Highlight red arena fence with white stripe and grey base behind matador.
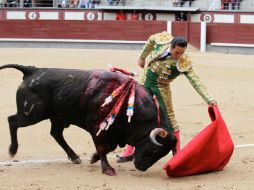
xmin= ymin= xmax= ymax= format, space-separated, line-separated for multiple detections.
xmin=0 ymin=20 xmax=254 ymax=54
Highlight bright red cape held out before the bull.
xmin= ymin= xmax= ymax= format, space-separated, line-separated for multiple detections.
xmin=163 ymin=106 xmax=234 ymax=176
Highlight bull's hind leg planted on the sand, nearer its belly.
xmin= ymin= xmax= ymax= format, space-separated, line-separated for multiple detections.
xmin=50 ymin=119 xmax=81 ymax=164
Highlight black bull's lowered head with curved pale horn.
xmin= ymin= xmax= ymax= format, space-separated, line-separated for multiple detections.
xmin=134 ymin=128 xmax=177 ymax=171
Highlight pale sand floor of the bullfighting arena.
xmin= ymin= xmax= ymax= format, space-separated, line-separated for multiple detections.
xmin=0 ymin=49 xmax=254 ymax=190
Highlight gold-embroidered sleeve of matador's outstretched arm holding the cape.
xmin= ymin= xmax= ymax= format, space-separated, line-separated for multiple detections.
xmin=184 ymin=68 xmax=214 ymax=104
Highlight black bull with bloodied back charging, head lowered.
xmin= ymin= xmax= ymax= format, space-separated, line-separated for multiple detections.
xmin=0 ymin=64 xmax=176 ymax=175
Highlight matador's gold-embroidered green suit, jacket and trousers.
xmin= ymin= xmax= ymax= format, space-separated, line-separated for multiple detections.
xmin=140 ymin=32 xmax=214 ymax=132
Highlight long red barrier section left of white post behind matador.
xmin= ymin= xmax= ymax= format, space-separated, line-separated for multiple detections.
xmin=0 ymin=20 xmax=167 ymax=41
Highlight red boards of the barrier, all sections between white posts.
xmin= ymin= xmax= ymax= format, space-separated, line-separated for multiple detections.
xmin=0 ymin=20 xmax=254 ymax=48
